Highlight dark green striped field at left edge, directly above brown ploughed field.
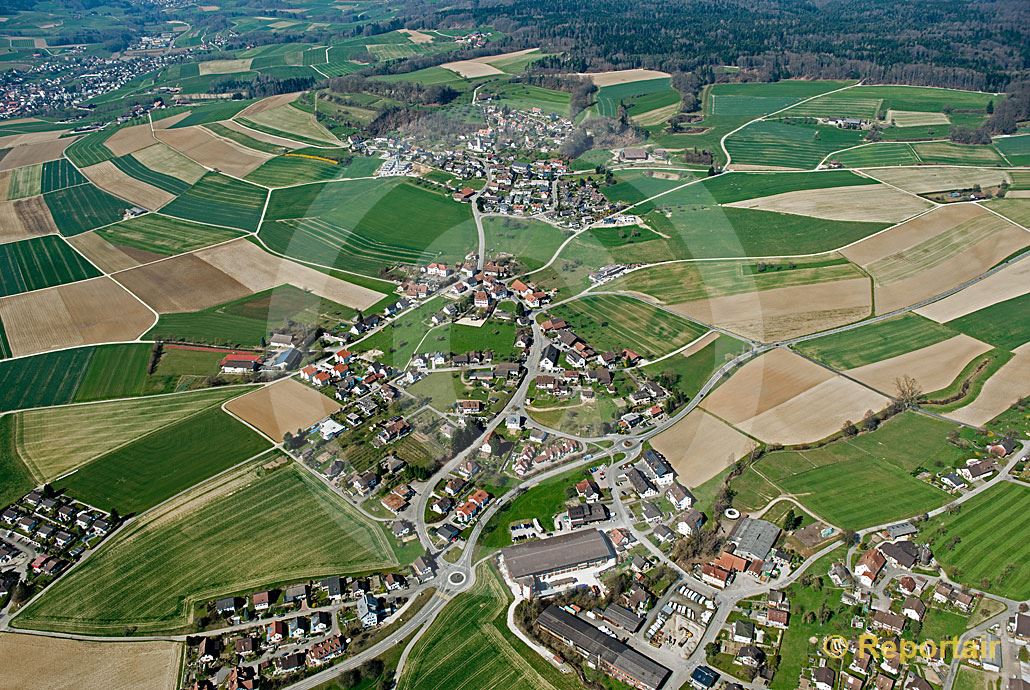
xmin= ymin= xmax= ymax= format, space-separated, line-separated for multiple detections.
xmin=0 ymin=235 xmax=100 ymax=297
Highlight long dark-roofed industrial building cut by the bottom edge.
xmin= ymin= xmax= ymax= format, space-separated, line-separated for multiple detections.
xmin=537 ymin=605 xmax=671 ymax=690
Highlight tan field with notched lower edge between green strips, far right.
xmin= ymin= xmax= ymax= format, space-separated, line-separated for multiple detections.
xmin=847 ymin=335 xmax=991 ymax=395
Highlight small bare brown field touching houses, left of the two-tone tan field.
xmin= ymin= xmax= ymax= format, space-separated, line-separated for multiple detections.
xmin=651 ymin=408 xmax=758 ymax=486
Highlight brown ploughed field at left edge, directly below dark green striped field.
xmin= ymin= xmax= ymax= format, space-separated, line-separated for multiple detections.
xmin=0 ymin=277 xmax=155 ymax=356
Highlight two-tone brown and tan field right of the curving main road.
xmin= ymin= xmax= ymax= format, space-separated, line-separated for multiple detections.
xmin=701 ymin=349 xmax=889 ymax=445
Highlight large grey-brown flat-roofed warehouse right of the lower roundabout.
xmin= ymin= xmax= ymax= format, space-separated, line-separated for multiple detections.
xmin=502 ymin=529 xmax=615 ymax=598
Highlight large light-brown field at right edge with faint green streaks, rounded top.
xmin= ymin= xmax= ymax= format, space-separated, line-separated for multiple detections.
xmin=840 ymin=204 xmax=1030 ymax=313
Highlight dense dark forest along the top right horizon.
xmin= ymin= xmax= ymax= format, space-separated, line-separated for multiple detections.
xmin=397 ymin=0 xmax=1030 ymax=91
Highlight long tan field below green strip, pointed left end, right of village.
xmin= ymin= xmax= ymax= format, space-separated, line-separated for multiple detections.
xmin=670 ymin=278 xmax=872 ymax=342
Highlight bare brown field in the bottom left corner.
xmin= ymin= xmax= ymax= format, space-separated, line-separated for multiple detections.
xmin=0 ymin=632 xmax=181 ymax=690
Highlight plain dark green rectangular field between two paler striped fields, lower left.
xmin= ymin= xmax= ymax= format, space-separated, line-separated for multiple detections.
xmin=57 ymin=408 xmax=270 ymax=515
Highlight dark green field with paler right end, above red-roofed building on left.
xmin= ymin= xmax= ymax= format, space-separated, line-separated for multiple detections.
xmin=145 ymin=284 xmax=355 ymax=347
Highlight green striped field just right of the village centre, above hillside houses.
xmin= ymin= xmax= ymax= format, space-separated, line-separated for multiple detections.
xmin=551 ymin=295 xmax=707 ymax=358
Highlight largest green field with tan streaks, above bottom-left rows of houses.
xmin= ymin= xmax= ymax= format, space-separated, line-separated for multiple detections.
xmin=16 ymin=460 xmax=399 ymax=635
